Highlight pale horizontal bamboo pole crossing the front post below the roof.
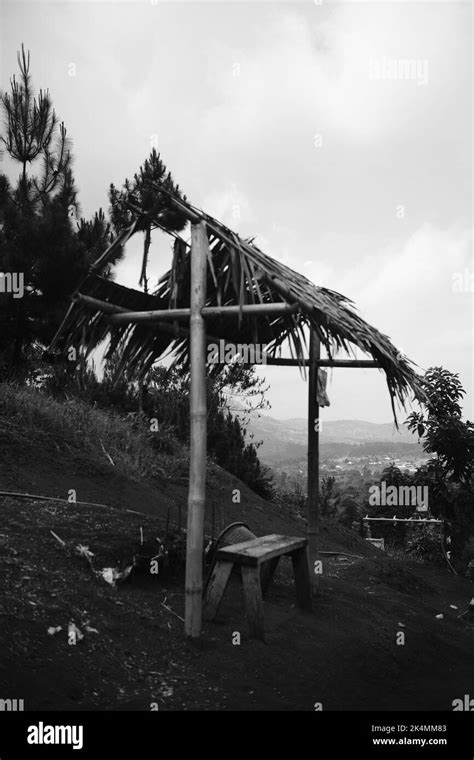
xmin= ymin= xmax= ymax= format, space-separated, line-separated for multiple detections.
xmin=110 ymin=302 xmax=298 ymax=324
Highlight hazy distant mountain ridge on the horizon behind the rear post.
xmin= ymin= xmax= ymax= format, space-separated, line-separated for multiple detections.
xmin=247 ymin=415 xmax=421 ymax=464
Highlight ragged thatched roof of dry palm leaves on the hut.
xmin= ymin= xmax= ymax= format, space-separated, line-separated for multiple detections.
xmin=52 ymin=185 xmax=423 ymax=422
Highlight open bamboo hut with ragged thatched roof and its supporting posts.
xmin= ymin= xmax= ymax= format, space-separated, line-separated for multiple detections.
xmin=51 ymin=183 xmax=423 ymax=636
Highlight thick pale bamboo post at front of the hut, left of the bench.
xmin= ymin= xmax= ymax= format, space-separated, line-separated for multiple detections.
xmin=184 ymin=222 xmax=208 ymax=638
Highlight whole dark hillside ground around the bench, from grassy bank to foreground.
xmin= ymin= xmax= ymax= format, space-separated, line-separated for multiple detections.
xmin=0 ymin=386 xmax=474 ymax=710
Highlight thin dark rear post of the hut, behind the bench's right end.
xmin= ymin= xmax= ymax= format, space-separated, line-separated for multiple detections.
xmin=307 ymin=330 xmax=321 ymax=596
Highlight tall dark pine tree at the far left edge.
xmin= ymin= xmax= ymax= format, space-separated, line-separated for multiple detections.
xmin=0 ymin=45 xmax=108 ymax=376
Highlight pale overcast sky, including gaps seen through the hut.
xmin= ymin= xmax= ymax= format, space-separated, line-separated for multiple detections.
xmin=0 ymin=0 xmax=474 ymax=422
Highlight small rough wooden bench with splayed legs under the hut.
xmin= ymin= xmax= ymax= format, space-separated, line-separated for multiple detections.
xmin=203 ymin=534 xmax=311 ymax=641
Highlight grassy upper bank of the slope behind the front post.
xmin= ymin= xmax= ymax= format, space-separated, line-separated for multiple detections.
xmin=0 ymin=386 xmax=378 ymax=553
